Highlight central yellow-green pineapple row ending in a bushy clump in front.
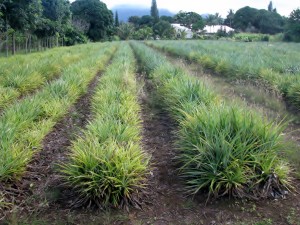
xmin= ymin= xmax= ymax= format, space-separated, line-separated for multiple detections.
xmin=62 ymin=43 xmax=149 ymax=207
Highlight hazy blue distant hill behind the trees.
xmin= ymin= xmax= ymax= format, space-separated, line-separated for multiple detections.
xmin=111 ymin=5 xmax=175 ymax=22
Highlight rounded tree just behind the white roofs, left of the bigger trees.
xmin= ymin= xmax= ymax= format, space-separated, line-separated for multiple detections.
xmin=174 ymin=11 xmax=204 ymax=30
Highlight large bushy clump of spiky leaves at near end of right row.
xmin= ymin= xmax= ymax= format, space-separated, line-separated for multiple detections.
xmin=177 ymin=105 xmax=289 ymax=197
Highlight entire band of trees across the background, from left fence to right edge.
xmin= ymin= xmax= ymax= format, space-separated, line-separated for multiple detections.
xmin=0 ymin=0 xmax=300 ymax=55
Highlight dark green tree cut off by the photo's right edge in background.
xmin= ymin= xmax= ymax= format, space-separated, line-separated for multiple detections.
xmin=285 ymin=8 xmax=300 ymax=42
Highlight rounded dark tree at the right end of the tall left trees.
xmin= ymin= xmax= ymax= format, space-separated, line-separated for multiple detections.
xmin=71 ymin=0 xmax=114 ymax=41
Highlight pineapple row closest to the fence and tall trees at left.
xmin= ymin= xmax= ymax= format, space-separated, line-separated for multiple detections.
xmin=0 ymin=45 xmax=93 ymax=109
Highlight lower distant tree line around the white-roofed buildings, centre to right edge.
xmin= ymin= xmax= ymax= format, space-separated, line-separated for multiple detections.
xmin=118 ymin=0 xmax=300 ymax=41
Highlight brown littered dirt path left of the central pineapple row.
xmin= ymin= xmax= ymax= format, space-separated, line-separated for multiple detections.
xmin=0 ymin=67 xmax=105 ymax=221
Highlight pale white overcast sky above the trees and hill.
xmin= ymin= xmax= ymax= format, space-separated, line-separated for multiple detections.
xmin=102 ymin=0 xmax=300 ymax=17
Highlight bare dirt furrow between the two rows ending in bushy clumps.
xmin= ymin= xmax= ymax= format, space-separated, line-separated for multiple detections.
xmin=132 ymin=75 xmax=190 ymax=224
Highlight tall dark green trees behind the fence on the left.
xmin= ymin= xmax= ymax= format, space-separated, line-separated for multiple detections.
xmin=0 ymin=0 xmax=113 ymax=55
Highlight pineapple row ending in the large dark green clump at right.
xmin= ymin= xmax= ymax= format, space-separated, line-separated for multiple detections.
xmin=131 ymin=42 xmax=290 ymax=198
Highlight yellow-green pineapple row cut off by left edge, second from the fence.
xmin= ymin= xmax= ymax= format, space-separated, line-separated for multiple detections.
xmin=0 ymin=44 xmax=117 ymax=182
